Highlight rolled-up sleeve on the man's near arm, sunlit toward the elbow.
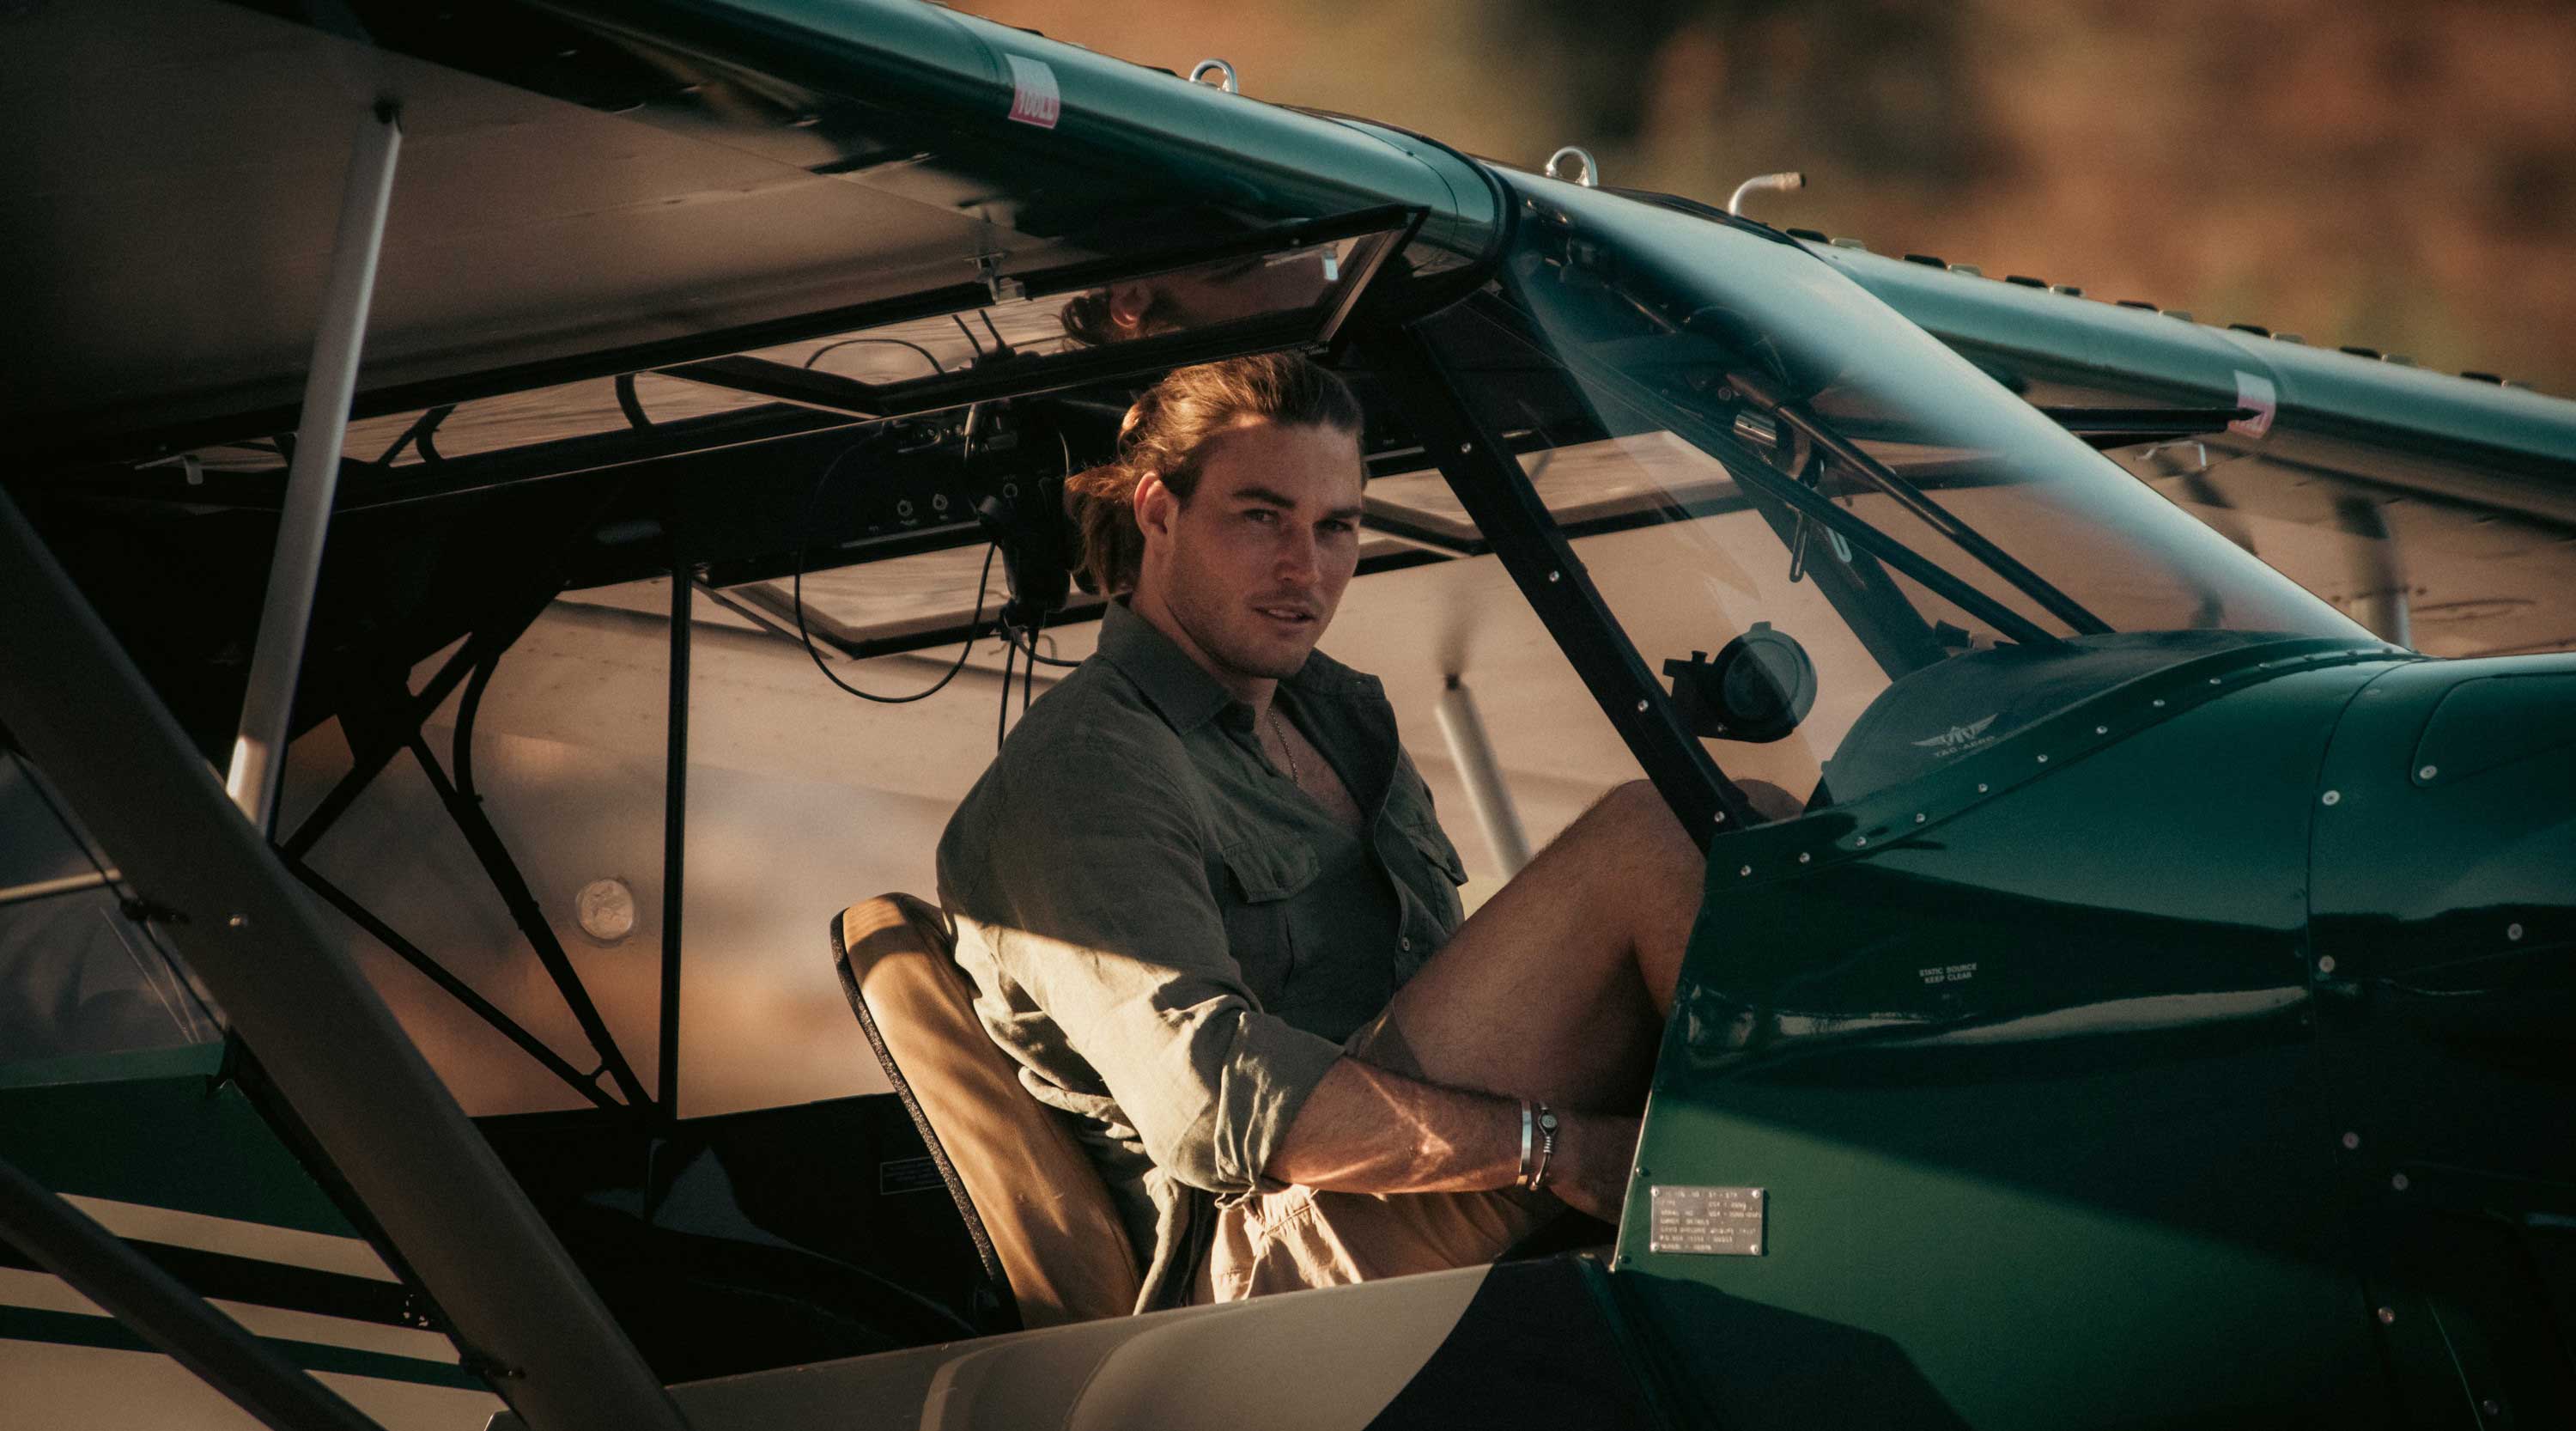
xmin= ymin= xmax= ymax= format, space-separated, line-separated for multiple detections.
xmin=940 ymin=740 xmax=1342 ymax=1194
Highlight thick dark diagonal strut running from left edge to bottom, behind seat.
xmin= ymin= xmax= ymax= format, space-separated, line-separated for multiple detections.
xmin=0 ymin=492 xmax=688 ymax=1431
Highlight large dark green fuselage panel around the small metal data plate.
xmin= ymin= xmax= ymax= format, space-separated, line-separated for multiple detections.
xmin=1615 ymin=642 xmax=2393 ymax=1428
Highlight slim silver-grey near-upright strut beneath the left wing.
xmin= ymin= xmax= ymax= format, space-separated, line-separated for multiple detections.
xmin=224 ymin=100 xmax=402 ymax=833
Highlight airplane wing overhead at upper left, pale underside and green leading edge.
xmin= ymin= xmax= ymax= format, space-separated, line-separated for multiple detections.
xmin=0 ymin=0 xmax=1497 ymax=474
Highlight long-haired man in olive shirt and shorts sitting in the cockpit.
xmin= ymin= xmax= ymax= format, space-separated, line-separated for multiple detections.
xmin=938 ymin=356 xmax=1703 ymax=1307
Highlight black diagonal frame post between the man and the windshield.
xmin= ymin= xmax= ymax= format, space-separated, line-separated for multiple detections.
xmin=1358 ymin=322 xmax=1762 ymax=849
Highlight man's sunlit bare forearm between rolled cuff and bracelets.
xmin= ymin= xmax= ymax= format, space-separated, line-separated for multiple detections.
xmin=1267 ymin=1057 xmax=1520 ymax=1194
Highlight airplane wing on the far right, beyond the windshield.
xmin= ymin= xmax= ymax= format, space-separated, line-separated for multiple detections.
xmin=1798 ymin=232 xmax=2576 ymax=657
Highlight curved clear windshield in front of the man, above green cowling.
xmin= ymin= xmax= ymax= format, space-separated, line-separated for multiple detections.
xmin=1412 ymin=173 xmax=2378 ymax=815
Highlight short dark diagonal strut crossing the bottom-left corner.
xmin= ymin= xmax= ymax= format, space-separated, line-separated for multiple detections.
xmin=0 ymin=1158 xmax=384 ymax=1431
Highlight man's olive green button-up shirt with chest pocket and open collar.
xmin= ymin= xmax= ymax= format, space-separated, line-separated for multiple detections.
xmin=938 ymin=603 xmax=1466 ymax=1310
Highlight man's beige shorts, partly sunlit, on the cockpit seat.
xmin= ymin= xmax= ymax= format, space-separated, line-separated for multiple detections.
xmin=1193 ymin=1014 xmax=1564 ymax=1302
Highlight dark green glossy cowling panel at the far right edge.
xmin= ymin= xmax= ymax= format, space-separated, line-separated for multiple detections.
xmin=2313 ymin=655 xmax=2576 ymax=1426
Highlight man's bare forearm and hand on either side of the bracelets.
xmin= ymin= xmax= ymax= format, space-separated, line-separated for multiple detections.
xmin=1265 ymin=1057 xmax=1636 ymax=1222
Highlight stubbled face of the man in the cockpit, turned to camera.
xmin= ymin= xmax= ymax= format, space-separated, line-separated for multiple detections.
xmin=1136 ymin=420 xmax=1360 ymax=693
